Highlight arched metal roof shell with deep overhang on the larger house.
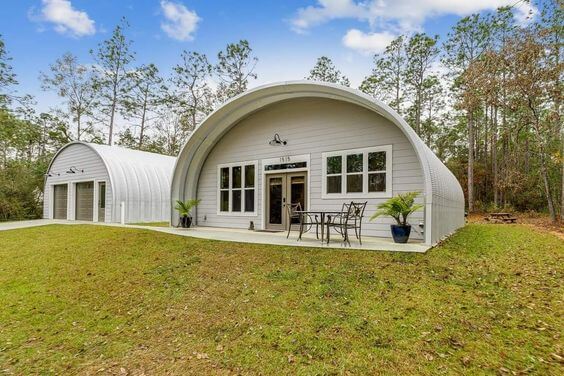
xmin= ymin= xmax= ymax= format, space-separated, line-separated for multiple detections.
xmin=171 ymin=81 xmax=464 ymax=244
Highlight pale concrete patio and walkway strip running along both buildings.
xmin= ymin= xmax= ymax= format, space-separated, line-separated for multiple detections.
xmin=0 ymin=219 xmax=430 ymax=253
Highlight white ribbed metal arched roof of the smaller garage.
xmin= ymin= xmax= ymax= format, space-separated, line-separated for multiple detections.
xmin=48 ymin=141 xmax=176 ymax=221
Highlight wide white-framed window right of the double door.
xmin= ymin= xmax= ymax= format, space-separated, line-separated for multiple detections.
xmin=322 ymin=145 xmax=392 ymax=198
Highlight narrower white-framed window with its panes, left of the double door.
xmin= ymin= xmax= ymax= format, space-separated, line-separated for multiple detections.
xmin=217 ymin=162 xmax=257 ymax=215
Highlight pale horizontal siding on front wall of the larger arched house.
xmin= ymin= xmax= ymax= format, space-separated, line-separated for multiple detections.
xmin=197 ymin=98 xmax=424 ymax=239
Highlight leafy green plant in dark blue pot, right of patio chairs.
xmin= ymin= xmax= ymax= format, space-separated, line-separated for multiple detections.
xmin=370 ymin=192 xmax=423 ymax=243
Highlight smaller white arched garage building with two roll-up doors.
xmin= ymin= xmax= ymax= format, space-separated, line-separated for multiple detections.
xmin=43 ymin=141 xmax=176 ymax=223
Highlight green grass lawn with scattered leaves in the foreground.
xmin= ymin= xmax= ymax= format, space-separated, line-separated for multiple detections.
xmin=0 ymin=224 xmax=564 ymax=375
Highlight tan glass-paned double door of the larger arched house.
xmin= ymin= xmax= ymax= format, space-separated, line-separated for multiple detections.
xmin=266 ymin=172 xmax=307 ymax=230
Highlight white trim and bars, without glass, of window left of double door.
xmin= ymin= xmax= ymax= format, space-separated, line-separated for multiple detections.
xmin=216 ymin=160 xmax=258 ymax=217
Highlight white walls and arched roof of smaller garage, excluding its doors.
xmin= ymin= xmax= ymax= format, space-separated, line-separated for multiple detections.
xmin=44 ymin=142 xmax=176 ymax=222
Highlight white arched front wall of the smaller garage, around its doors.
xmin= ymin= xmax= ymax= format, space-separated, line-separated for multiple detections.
xmin=43 ymin=143 xmax=113 ymax=222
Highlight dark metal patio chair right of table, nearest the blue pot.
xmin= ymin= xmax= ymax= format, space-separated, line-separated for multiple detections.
xmin=327 ymin=201 xmax=368 ymax=246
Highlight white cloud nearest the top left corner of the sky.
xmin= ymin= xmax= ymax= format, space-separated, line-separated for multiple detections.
xmin=35 ymin=0 xmax=96 ymax=38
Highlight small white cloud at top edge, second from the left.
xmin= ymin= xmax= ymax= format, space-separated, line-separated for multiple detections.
xmin=161 ymin=0 xmax=201 ymax=41
